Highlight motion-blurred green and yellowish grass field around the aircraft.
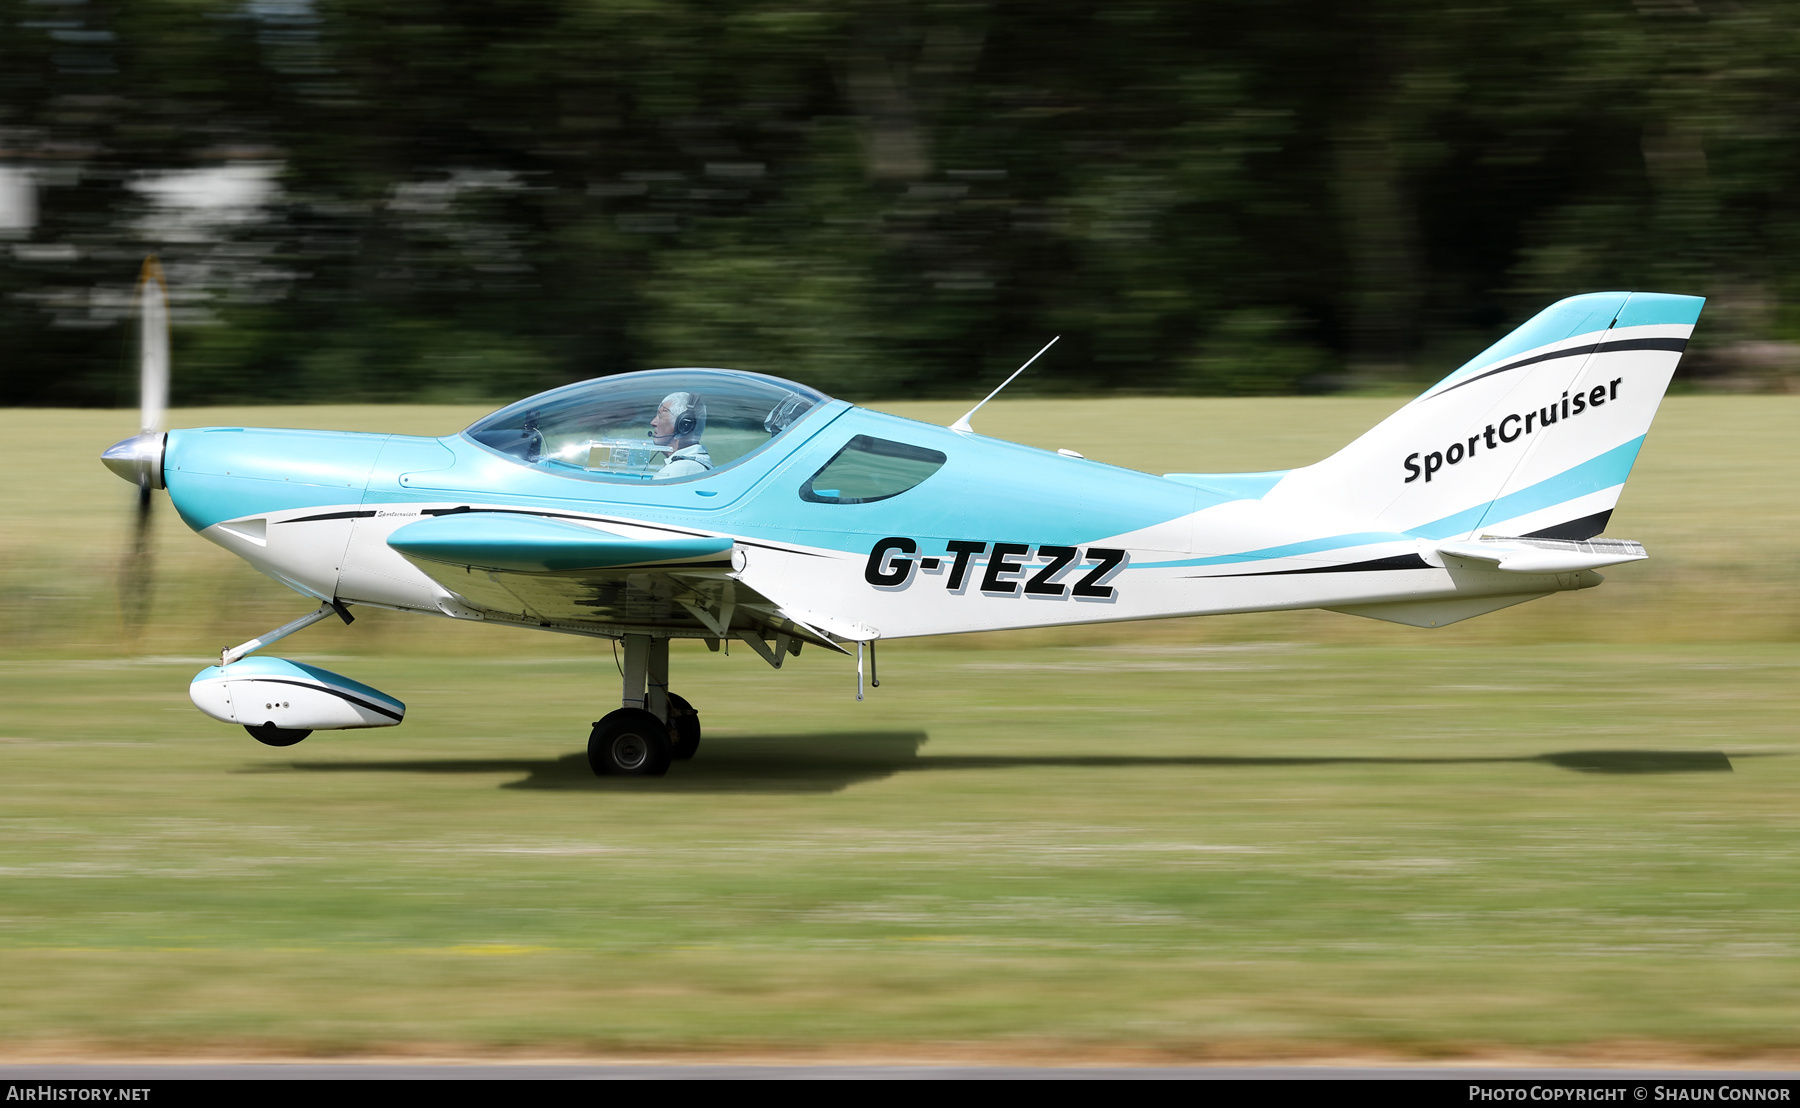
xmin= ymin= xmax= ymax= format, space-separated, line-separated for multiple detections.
xmin=0 ymin=398 xmax=1800 ymax=1061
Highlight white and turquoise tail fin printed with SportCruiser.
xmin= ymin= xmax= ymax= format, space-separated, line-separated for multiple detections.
xmin=1271 ymin=293 xmax=1705 ymax=540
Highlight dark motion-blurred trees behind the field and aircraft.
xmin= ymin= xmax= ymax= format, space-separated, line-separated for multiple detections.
xmin=0 ymin=0 xmax=1800 ymax=405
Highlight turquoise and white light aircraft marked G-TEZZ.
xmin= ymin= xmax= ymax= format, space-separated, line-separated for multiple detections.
xmin=103 ymin=275 xmax=1703 ymax=775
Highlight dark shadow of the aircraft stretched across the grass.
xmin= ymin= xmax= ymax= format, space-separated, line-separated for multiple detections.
xmin=263 ymin=730 xmax=1732 ymax=793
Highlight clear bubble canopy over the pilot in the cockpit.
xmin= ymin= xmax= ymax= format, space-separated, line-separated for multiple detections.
xmin=463 ymin=369 xmax=832 ymax=482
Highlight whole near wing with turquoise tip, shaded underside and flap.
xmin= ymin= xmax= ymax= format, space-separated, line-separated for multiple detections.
xmin=387 ymin=509 xmax=848 ymax=666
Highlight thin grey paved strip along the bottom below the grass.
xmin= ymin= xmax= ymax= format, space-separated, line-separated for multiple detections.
xmin=0 ymin=1063 xmax=1800 ymax=1085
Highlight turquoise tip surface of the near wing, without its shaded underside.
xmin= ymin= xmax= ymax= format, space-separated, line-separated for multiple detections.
xmin=387 ymin=511 xmax=733 ymax=574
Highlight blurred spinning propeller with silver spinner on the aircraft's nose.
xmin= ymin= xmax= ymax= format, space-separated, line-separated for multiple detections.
xmin=115 ymin=255 xmax=169 ymax=625
